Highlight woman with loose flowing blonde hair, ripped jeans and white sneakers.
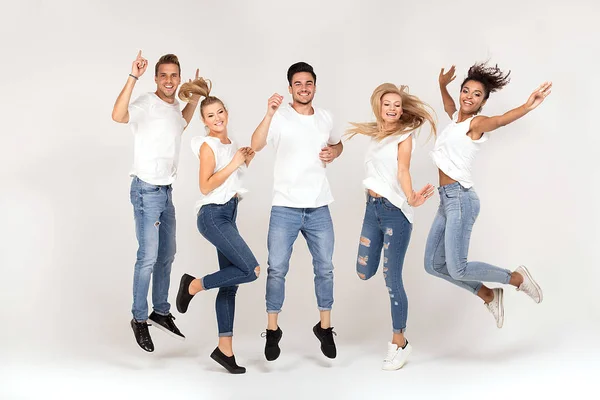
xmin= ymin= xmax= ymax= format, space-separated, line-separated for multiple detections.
xmin=347 ymin=83 xmax=436 ymax=371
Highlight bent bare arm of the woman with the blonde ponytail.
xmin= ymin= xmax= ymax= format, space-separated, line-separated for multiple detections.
xmin=198 ymin=143 xmax=249 ymax=195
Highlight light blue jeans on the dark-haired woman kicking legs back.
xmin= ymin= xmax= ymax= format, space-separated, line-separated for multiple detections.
xmin=425 ymin=182 xmax=511 ymax=294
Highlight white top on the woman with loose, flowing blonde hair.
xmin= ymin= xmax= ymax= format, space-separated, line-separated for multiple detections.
xmin=363 ymin=132 xmax=416 ymax=223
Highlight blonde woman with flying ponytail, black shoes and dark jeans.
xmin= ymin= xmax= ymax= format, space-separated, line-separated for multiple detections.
xmin=176 ymin=78 xmax=260 ymax=374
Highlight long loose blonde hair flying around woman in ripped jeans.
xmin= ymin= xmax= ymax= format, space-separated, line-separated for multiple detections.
xmin=346 ymin=83 xmax=437 ymax=141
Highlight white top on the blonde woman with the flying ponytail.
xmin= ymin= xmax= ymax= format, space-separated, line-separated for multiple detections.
xmin=192 ymin=136 xmax=248 ymax=214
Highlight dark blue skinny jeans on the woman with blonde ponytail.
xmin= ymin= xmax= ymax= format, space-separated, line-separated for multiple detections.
xmin=197 ymin=197 xmax=260 ymax=336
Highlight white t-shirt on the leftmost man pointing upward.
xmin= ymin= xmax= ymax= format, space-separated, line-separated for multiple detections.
xmin=128 ymin=93 xmax=187 ymax=185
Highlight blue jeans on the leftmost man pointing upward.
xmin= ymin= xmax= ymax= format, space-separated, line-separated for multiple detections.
xmin=129 ymin=177 xmax=176 ymax=321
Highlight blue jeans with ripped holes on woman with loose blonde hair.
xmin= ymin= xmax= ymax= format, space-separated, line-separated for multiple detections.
xmin=356 ymin=194 xmax=412 ymax=333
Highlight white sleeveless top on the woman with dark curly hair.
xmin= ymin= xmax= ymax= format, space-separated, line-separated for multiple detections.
xmin=430 ymin=111 xmax=488 ymax=189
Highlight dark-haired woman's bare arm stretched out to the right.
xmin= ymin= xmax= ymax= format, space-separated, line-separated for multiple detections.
xmin=470 ymin=82 xmax=552 ymax=138
